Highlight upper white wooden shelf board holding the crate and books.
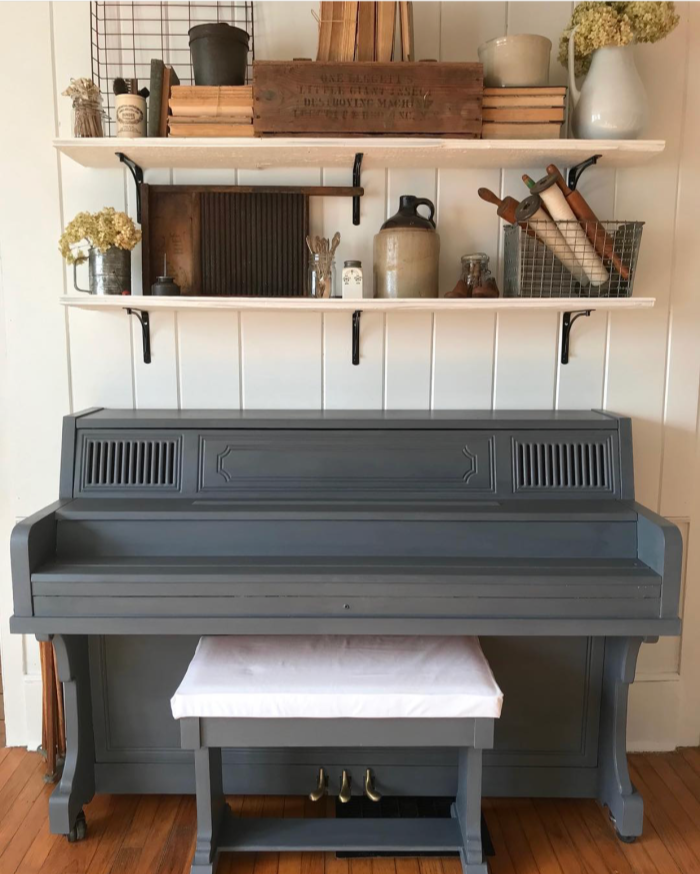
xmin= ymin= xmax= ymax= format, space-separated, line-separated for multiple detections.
xmin=53 ymin=137 xmax=666 ymax=170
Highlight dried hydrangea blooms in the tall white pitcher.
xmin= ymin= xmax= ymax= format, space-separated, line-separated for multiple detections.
xmin=559 ymin=2 xmax=680 ymax=76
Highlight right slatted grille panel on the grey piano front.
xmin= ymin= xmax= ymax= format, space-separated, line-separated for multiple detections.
xmin=513 ymin=440 xmax=614 ymax=492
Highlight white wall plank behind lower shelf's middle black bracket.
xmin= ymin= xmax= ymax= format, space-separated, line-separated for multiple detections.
xmin=323 ymin=313 xmax=384 ymax=410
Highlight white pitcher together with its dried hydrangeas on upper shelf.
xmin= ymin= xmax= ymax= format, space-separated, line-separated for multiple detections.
xmin=559 ymin=2 xmax=679 ymax=140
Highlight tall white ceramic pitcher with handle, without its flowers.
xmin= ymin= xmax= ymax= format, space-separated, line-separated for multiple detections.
xmin=569 ymin=32 xmax=647 ymax=140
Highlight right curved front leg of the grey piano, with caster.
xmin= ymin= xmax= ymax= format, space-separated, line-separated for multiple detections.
xmin=598 ymin=637 xmax=644 ymax=843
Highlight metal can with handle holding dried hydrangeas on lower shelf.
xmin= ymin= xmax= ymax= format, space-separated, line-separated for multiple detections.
xmin=58 ymin=206 xmax=141 ymax=294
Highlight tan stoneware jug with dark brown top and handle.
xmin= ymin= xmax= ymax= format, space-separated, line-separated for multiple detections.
xmin=374 ymin=194 xmax=440 ymax=298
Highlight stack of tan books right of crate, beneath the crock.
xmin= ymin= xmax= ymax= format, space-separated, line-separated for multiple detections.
xmin=481 ymin=85 xmax=566 ymax=140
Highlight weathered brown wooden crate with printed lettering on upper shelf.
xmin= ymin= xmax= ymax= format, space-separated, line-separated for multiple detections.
xmin=253 ymin=61 xmax=483 ymax=138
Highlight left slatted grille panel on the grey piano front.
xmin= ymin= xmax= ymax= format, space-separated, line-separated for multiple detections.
xmin=83 ymin=438 xmax=180 ymax=489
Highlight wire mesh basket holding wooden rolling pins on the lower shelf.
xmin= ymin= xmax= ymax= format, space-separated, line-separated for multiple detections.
xmin=503 ymin=221 xmax=644 ymax=297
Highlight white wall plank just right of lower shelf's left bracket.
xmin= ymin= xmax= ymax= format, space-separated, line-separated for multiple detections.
xmin=178 ymin=311 xmax=241 ymax=410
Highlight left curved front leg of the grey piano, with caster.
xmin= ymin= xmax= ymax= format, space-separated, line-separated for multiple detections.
xmin=41 ymin=635 xmax=95 ymax=841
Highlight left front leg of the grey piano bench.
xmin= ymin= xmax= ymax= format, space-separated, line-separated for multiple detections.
xmin=191 ymin=747 xmax=226 ymax=874
